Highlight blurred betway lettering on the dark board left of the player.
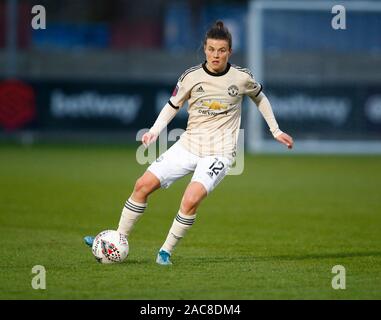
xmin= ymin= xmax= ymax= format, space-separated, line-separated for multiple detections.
xmin=50 ymin=90 xmax=142 ymax=123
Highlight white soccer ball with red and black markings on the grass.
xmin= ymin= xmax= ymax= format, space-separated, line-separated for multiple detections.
xmin=92 ymin=230 xmax=129 ymax=263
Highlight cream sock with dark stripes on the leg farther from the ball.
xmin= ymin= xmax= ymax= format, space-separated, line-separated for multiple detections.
xmin=160 ymin=211 xmax=196 ymax=254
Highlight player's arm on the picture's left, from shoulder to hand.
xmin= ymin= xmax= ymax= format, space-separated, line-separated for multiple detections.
xmin=142 ymin=73 xmax=192 ymax=147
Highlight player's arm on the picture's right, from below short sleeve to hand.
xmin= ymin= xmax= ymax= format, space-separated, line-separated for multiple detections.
xmin=251 ymin=92 xmax=294 ymax=149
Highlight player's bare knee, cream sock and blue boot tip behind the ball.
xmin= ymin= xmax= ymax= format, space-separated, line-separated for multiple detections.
xmin=83 ymin=171 xmax=160 ymax=247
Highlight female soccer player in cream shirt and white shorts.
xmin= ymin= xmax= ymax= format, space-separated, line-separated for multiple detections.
xmin=85 ymin=21 xmax=293 ymax=265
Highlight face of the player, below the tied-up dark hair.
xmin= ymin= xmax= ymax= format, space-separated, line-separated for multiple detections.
xmin=204 ymin=39 xmax=232 ymax=73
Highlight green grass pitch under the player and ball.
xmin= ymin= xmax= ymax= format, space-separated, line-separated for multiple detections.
xmin=0 ymin=145 xmax=381 ymax=300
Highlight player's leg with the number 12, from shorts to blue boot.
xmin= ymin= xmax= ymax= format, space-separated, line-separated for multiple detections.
xmin=156 ymin=157 xmax=231 ymax=265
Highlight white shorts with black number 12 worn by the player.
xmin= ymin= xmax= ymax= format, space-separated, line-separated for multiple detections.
xmin=147 ymin=141 xmax=231 ymax=193
